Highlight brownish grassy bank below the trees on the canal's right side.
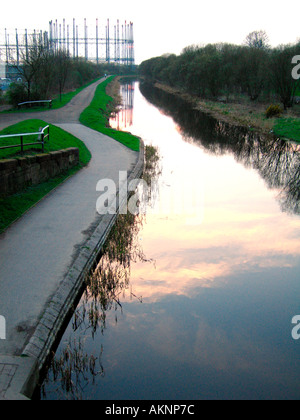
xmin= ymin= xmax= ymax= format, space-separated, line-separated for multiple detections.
xmin=155 ymin=83 xmax=300 ymax=142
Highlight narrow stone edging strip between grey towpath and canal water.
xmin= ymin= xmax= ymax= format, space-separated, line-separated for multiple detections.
xmin=0 ymin=140 xmax=145 ymax=400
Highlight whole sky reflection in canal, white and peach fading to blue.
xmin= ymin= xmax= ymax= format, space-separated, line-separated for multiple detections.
xmin=42 ymin=83 xmax=300 ymax=400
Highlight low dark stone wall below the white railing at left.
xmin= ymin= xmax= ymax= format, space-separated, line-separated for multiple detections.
xmin=0 ymin=147 xmax=79 ymax=197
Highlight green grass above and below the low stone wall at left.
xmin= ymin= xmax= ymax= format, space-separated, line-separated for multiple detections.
xmin=0 ymin=120 xmax=91 ymax=233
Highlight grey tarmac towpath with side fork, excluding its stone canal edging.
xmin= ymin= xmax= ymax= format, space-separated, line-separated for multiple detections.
xmin=0 ymin=78 xmax=139 ymax=398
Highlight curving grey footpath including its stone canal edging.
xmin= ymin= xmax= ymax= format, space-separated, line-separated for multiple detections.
xmin=0 ymin=79 xmax=144 ymax=400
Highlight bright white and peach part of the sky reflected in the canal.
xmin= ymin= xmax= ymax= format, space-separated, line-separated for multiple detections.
xmin=125 ymin=86 xmax=300 ymax=299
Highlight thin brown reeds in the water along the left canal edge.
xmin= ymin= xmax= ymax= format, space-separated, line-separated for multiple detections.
xmin=41 ymin=148 xmax=159 ymax=400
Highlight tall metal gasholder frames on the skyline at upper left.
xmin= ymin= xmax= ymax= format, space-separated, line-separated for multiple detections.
xmin=0 ymin=19 xmax=135 ymax=77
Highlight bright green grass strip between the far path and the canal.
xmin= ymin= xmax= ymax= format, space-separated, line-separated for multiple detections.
xmin=80 ymin=77 xmax=140 ymax=151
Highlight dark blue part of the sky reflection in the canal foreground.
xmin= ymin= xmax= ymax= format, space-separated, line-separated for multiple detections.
xmin=101 ymin=270 xmax=299 ymax=399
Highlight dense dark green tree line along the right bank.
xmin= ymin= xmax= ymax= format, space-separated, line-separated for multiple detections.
xmin=139 ymin=31 xmax=300 ymax=109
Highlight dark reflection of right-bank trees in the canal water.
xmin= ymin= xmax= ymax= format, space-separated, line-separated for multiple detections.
xmin=140 ymin=83 xmax=300 ymax=214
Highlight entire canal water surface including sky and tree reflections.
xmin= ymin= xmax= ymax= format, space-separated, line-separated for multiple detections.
xmin=40 ymin=83 xmax=300 ymax=400
